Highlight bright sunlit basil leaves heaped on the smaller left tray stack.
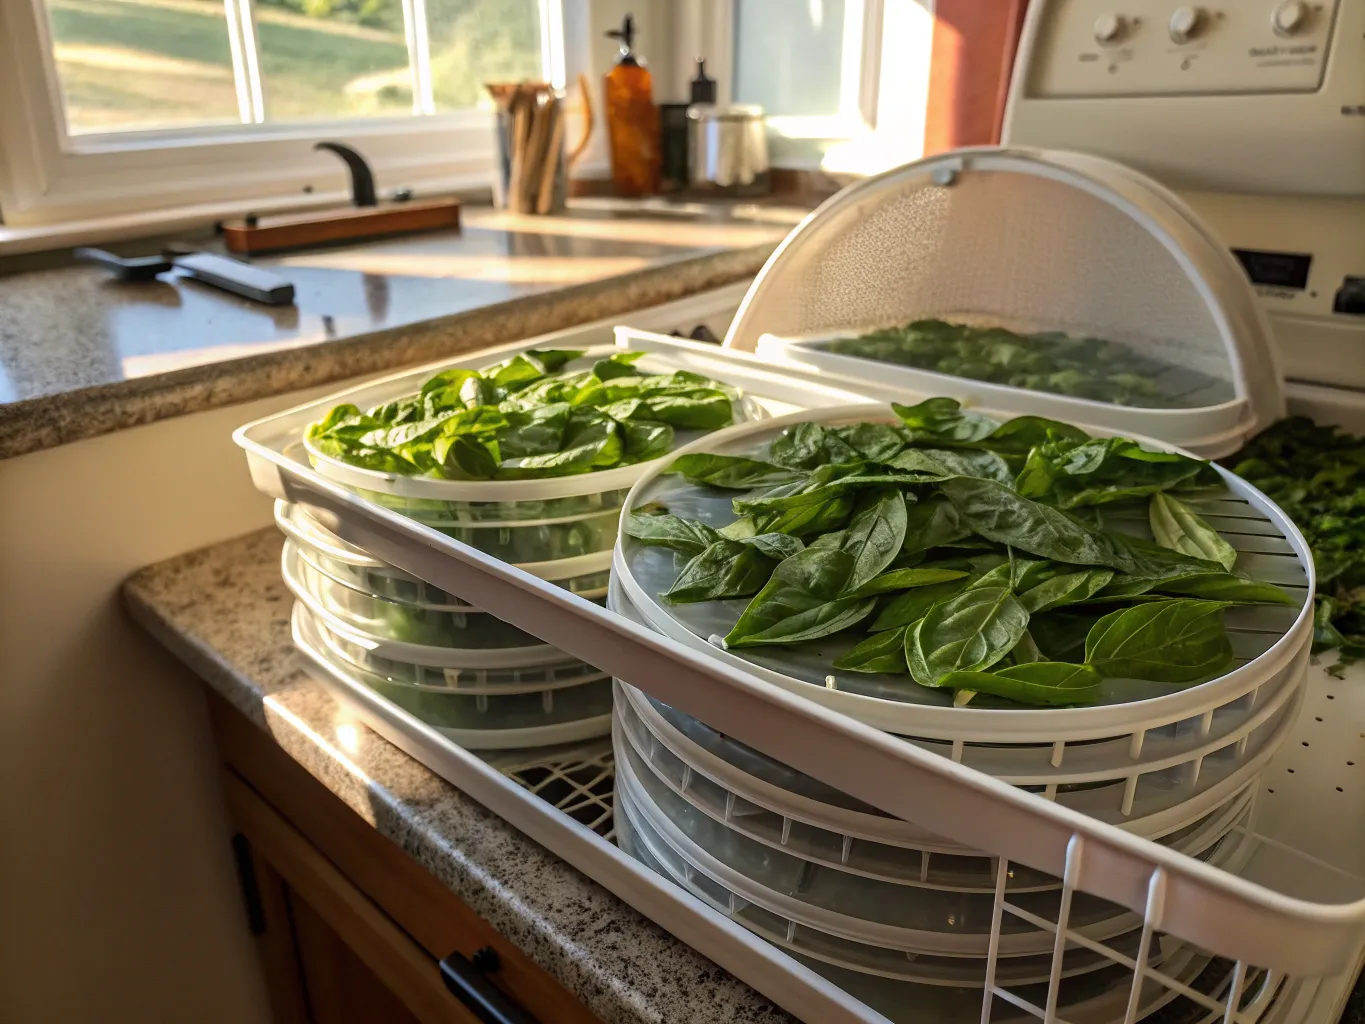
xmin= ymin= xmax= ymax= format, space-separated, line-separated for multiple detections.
xmin=307 ymin=350 xmax=738 ymax=481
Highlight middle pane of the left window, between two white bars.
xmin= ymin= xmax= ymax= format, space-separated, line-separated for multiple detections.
xmin=254 ymin=0 xmax=412 ymax=122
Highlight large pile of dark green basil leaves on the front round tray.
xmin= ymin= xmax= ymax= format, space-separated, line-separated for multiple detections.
xmin=625 ymin=399 xmax=1294 ymax=706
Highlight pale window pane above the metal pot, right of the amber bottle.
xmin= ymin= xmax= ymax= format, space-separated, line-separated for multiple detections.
xmin=734 ymin=0 xmax=840 ymax=117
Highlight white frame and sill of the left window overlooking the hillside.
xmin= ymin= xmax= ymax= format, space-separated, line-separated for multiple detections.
xmin=0 ymin=0 xmax=573 ymax=231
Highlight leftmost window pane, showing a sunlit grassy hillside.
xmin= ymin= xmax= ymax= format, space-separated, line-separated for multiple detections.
xmin=46 ymin=0 xmax=238 ymax=134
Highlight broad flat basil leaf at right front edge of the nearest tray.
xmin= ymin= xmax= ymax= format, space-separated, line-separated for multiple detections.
xmin=1085 ymin=601 xmax=1233 ymax=683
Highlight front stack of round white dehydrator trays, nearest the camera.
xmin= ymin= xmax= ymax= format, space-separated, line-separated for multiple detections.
xmin=610 ymin=406 xmax=1312 ymax=1020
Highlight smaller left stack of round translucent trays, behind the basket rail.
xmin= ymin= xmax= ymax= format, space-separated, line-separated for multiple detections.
xmin=266 ymin=308 xmax=873 ymax=750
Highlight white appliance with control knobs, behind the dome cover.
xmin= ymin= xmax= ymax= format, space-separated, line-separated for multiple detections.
xmin=1005 ymin=0 xmax=1365 ymax=420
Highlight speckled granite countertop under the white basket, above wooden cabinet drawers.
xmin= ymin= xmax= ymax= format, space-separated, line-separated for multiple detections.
xmin=124 ymin=530 xmax=793 ymax=1024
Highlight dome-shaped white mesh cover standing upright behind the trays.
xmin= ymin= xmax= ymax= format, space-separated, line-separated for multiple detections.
xmin=725 ymin=147 xmax=1283 ymax=456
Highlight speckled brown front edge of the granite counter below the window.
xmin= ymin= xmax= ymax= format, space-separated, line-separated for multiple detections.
xmin=0 ymin=242 xmax=777 ymax=459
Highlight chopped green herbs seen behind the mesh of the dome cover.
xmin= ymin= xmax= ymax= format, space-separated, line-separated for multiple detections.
xmin=826 ymin=319 xmax=1218 ymax=408
